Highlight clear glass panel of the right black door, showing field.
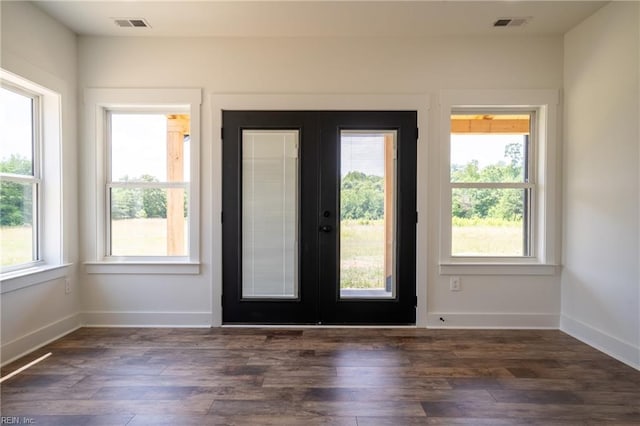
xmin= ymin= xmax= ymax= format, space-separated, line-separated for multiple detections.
xmin=339 ymin=130 xmax=396 ymax=299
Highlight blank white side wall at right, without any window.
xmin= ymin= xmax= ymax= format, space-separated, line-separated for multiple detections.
xmin=561 ymin=2 xmax=640 ymax=368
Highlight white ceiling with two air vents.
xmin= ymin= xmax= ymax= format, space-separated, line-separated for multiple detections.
xmin=34 ymin=0 xmax=607 ymax=37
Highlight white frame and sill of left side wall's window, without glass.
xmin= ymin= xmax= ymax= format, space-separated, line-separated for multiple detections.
xmin=0 ymin=69 xmax=70 ymax=293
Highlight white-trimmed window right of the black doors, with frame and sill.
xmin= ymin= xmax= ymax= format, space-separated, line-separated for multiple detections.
xmin=440 ymin=90 xmax=559 ymax=274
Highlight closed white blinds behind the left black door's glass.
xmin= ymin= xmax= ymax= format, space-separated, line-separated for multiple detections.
xmin=242 ymin=130 xmax=299 ymax=298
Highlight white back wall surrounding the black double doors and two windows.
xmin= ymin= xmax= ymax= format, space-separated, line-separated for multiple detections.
xmin=79 ymin=37 xmax=562 ymax=327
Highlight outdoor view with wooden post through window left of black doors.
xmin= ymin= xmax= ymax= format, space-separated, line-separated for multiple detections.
xmin=107 ymin=112 xmax=190 ymax=256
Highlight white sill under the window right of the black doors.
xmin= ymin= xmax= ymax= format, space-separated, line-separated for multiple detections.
xmin=440 ymin=263 xmax=559 ymax=275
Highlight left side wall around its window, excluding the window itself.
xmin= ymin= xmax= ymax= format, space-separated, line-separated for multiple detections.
xmin=0 ymin=2 xmax=80 ymax=363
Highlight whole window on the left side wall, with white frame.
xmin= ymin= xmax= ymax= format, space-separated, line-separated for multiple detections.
xmin=0 ymin=69 xmax=68 ymax=284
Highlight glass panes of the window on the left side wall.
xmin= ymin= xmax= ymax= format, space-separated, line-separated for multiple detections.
xmin=0 ymin=85 xmax=41 ymax=271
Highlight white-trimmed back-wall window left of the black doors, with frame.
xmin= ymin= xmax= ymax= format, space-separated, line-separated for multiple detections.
xmin=85 ymin=89 xmax=201 ymax=273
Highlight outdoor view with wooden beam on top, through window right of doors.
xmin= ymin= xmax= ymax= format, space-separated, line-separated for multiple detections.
xmin=450 ymin=114 xmax=533 ymax=257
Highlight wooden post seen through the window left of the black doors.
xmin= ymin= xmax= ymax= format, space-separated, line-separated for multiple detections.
xmin=167 ymin=115 xmax=189 ymax=256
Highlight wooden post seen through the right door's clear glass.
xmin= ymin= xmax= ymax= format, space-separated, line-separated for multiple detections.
xmin=384 ymin=133 xmax=395 ymax=291
